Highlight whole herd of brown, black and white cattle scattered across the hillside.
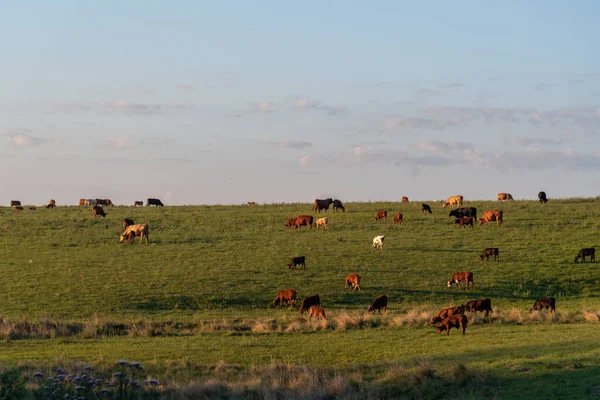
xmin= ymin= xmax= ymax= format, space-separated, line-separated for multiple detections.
xmin=3 ymin=192 xmax=584 ymax=335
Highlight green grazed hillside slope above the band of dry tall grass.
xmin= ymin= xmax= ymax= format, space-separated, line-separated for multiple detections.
xmin=0 ymin=199 xmax=600 ymax=321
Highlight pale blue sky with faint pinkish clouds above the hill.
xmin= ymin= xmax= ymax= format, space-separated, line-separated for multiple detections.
xmin=0 ymin=0 xmax=600 ymax=206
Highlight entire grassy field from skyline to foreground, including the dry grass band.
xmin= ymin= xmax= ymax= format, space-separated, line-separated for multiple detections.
xmin=0 ymin=199 xmax=600 ymax=399
